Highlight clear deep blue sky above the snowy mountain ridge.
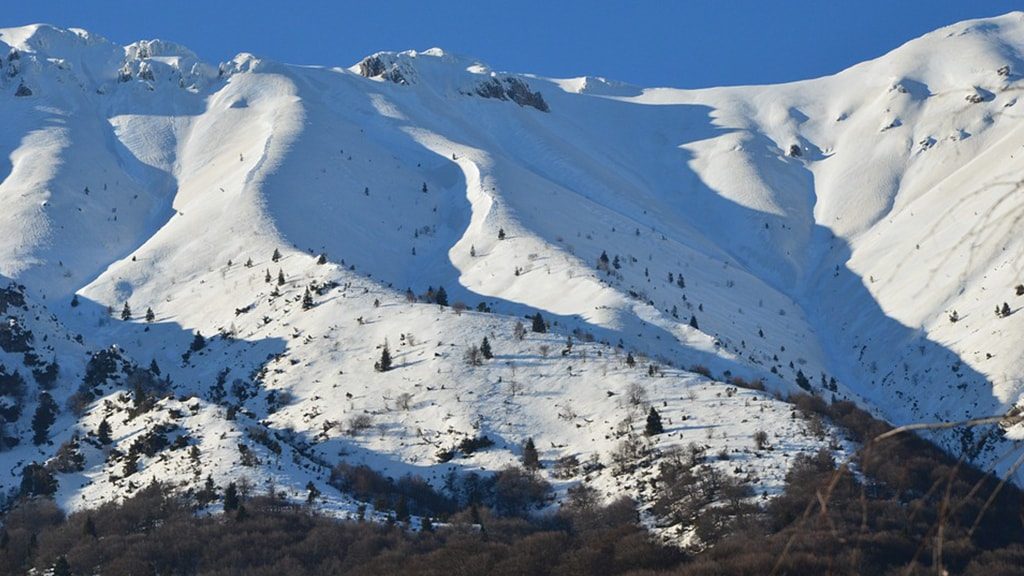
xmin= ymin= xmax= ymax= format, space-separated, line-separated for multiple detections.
xmin=8 ymin=0 xmax=1024 ymax=87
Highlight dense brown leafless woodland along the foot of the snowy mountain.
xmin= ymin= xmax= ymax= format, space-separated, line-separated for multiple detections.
xmin=0 ymin=396 xmax=1024 ymax=576
